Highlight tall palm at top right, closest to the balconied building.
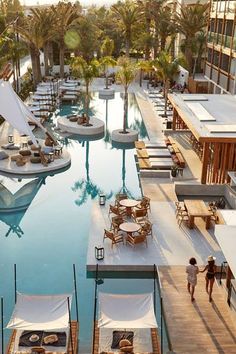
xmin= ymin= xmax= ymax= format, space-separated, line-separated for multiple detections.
xmin=175 ymin=1 xmax=209 ymax=74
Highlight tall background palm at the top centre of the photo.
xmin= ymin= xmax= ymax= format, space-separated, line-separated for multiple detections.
xmin=111 ymin=0 xmax=139 ymax=57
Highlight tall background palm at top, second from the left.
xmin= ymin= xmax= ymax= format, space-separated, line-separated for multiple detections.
xmin=52 ymin=1 xmax=80 ymax=78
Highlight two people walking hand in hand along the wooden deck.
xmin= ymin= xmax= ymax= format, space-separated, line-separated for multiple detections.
xmin=186 ymin=256 xmax=216 ymax=302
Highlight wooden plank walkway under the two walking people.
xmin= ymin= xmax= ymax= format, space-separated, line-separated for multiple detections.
xmin=159 ymin=266 xmax=236 ymax=354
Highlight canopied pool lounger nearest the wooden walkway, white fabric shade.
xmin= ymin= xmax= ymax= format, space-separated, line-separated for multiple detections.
xmin=93 ymin=293 xmax=158 ymax=354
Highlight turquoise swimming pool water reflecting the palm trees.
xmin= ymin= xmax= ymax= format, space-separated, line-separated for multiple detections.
xmin=0 ymin=93 xmax=166 ymax=353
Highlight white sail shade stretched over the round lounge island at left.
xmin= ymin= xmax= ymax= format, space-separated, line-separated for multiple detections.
xmin=0 ymin=80 xmax=44 ymax=145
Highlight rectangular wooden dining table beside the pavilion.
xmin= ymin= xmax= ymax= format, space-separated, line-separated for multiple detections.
xmin=184 ymin=199 xmax=212 ymax=229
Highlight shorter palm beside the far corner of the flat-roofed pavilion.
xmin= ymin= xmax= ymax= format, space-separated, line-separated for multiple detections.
xmin=153 ymin=52 xmax=179 ymax=115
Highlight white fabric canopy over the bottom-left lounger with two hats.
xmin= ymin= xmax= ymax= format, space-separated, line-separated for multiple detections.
xmin=7 ymin=293 xmax=72 ymax=331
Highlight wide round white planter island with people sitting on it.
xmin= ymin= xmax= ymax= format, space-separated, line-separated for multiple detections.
xmin=57 ymin=117 xmax=105 ymax=136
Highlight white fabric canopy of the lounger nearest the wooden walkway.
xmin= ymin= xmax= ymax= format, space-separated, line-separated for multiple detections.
xmin=98 ymin=293 xmax=157 ymax=329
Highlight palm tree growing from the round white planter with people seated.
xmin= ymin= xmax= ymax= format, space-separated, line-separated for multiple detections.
xmin=72 ymin=57 xmax=99 ymax=125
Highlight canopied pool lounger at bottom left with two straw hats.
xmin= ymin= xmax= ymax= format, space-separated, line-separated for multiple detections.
xmin=6 ymin=293 xmax=78 ymax=354
